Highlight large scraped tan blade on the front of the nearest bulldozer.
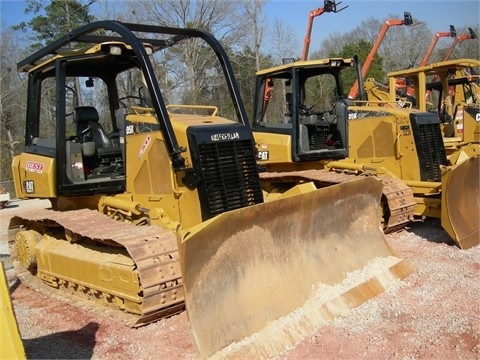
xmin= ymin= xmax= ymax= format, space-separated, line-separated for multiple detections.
xmin=180 ymin=178 xmax=413 ymax=358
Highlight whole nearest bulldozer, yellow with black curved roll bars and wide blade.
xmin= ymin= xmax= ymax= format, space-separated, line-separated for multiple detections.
xmin=9 ymin=21 xmax=412 ymax=357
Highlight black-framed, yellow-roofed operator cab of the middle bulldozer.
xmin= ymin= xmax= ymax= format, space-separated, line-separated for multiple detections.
xmin=252 ymin=59 xmax=353 ymax=161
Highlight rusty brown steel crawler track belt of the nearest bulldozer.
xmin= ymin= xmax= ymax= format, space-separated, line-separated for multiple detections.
xmin=9 ymin=209 xmax=185 ymax=327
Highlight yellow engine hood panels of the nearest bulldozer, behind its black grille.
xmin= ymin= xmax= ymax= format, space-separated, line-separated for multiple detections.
xmin=120 ymin=111 xmax=244 ymax=229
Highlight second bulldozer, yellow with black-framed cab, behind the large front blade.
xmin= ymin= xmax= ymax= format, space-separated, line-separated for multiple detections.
xmin=252 ymin=58 xmax=479 ymax=248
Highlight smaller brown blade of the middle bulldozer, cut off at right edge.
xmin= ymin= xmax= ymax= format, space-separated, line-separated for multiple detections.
xmin=441 ymin=155 xmax=480 ymax=249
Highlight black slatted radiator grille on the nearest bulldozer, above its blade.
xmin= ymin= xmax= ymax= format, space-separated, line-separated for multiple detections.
xmin=188 ymin=125 xmax=263 ymax=221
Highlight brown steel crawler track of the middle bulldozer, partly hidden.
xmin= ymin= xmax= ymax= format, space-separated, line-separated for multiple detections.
xmin=260 ymin=170 xmax=416 ymax=233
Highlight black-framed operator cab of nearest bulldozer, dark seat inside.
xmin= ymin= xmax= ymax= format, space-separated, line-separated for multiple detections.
xmin=19 ymin=42 xmax=152 ymax=195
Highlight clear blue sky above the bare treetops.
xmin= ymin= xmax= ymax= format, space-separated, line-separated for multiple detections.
xmin=0 ymin=0 xmax=480 ymax=51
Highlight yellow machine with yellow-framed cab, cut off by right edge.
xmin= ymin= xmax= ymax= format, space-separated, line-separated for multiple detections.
xmin=388 ymin=59 xmax=480 ymax=158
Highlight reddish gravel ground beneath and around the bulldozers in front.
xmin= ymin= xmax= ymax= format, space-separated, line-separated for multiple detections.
xmin=0 ymin=200 xmax=480 ymax=360
